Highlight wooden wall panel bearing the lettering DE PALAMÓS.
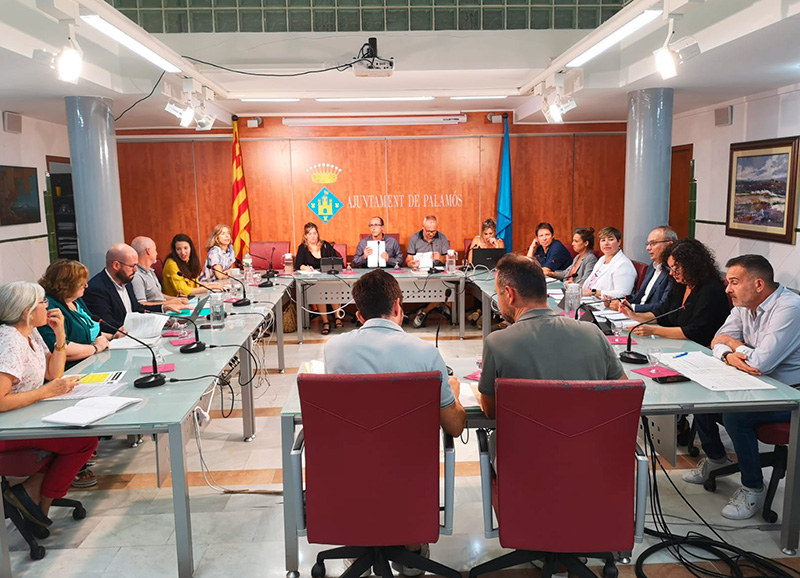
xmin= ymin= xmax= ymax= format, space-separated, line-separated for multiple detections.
xmin=387 ymin=138 xmax=481 ymax=261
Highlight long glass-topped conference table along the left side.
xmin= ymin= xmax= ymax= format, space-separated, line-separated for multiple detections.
xmin=0 ymin=283 xmax=289 ymax=578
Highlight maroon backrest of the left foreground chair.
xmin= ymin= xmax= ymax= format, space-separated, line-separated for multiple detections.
xmin=297 ymin=372 xmax=441 ymax=546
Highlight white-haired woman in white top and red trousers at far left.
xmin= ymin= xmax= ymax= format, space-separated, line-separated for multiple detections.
xmin=0 ymin=281 xmax=97 ymax=528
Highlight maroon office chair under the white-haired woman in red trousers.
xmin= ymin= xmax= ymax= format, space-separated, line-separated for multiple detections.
xmin=0 ymin=450 xmax=86 ymax=560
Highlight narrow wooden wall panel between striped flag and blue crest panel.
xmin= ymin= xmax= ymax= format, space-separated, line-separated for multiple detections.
xmin=241 ymin=140 xmax=297 ymax=250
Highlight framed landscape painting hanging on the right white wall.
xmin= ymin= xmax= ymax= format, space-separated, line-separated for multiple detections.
xmin=725 ymin=137 xmax=800 ymax=245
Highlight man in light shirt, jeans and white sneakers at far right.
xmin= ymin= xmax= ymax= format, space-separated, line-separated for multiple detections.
xmin=683 ymin=255 xmax=800 ymax=520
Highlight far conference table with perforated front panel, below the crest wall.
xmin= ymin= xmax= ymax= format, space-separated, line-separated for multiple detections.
xmin=294 ymin=268 xmax=466 ymax=343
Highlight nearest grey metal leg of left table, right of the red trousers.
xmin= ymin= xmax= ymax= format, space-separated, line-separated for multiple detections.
xmin=169 ymin=414 xmax=194 ymax=578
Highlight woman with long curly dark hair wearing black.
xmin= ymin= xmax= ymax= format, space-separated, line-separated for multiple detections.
xmin=619 ymin=239 xmax=731 ymax=347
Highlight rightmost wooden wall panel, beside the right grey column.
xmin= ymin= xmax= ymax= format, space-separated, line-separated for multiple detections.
xmin=573 ymin=134 xmax=625 ymax=248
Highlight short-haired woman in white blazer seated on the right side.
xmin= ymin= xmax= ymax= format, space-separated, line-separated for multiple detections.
xmin=583 ymin=227 xmax=636 ymax=297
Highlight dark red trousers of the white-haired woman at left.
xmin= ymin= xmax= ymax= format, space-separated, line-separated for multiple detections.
xmin=0 ymin=437 xmax=97 ymax=499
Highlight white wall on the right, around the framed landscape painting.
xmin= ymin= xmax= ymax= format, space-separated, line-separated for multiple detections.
xmin=672 ymin=84 xmax=800 ymax=288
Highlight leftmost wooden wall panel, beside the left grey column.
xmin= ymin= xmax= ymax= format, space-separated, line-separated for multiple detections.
xmin=117 ymin=142 xmax=198 ymax=258
